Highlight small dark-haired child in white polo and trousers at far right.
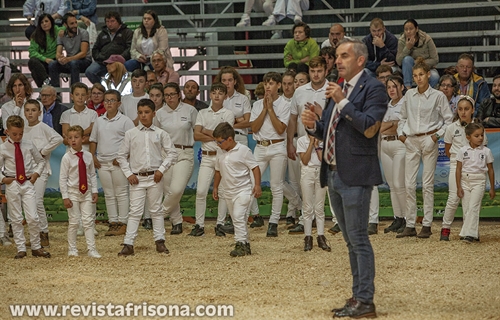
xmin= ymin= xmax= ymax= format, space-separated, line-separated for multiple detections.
xmin=456 ymin=123 xmax=495 ymax=243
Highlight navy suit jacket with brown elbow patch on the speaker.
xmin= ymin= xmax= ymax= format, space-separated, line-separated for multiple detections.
xmin=314 ymin=71 xmax=387 ymax=187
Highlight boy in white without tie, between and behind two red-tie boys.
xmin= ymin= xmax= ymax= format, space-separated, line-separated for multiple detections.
xmin=24 ymin=99 xmax=63 ymax=247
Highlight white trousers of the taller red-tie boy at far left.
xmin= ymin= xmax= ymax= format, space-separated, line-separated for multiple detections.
xmin=5 ymin=181 xmax=41 ymax=252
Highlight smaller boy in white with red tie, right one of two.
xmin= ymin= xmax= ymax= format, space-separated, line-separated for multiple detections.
xmin=59 ymin=126 xmax=101 ymax=258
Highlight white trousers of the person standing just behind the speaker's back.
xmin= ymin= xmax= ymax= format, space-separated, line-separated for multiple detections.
xmin=380 ymin=140 xmax=406 ymax=218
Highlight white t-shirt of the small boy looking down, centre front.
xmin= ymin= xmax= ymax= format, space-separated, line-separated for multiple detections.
xmin=215 ymin=142 xmax=259 ymax=199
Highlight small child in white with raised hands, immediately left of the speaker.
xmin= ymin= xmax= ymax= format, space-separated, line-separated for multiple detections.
xmin=297 ymin=135 xmax=331 ymax=251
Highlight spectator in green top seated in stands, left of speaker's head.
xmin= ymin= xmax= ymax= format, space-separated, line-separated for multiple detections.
xmin=283 ymin=22 xmax=319 ymax=72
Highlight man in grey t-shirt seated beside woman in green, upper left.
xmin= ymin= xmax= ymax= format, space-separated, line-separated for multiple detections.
xmin=49 ymin=13 xmax=92 ymax=88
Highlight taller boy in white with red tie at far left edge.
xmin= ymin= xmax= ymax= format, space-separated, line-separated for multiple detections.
xmin=0 ymin=116 xmax=50 ymax=259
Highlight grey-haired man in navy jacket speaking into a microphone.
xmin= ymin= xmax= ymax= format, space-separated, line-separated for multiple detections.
xmin=302 ymin=39 xmax=387 ymax=318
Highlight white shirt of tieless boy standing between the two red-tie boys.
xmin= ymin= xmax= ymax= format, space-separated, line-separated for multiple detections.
xmin=23 ymin=122 xmax=63 ymax=175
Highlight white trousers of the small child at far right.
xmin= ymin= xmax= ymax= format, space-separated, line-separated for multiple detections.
xmin=460 ymin=173 xmax=486 ymax=238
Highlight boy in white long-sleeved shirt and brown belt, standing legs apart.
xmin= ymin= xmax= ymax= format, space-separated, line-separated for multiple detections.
xmin=117 ymin=99 xmax=177 ymax=256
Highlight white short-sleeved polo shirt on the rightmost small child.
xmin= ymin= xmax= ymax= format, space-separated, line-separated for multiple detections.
xmin=457 ymin=144 xmax=493 ymax=174
